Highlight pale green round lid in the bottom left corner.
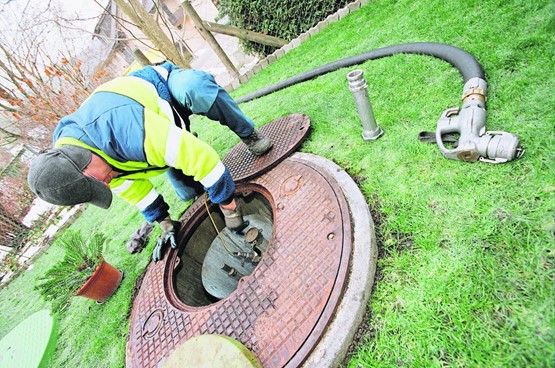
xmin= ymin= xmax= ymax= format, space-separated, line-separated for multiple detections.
xmin=0 ymin=310 xmax=59 ymax=368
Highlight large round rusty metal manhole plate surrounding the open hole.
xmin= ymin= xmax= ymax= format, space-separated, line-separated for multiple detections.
xmin=126 ymin=158 xmax=352 ymax=368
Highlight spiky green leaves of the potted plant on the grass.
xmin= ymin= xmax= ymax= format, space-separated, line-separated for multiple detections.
xmin=35 ymin=231 xmax=106 ymax=313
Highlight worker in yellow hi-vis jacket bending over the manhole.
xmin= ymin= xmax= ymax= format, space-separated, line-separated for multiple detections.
xmin=28 ymin=62 xmax=272 ymax=261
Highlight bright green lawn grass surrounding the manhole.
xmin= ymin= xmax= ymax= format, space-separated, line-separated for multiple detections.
xmin=0 ymin=0 xmax=555 ymax=368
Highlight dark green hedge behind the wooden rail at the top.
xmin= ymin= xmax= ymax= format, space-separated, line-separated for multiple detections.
xmin=220 ymin=0 xmax=349 ymax=55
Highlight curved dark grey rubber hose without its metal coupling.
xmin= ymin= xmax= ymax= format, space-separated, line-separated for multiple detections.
xmin=235 ymin=42 xmax=484 ymax=103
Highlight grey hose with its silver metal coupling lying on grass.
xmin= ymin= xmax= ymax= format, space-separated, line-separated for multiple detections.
xmin=236 ymin=42 xmax=524 ymax=164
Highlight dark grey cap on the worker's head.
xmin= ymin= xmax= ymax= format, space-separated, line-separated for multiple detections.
xmin=27 ymin=146 xmax=112 ymax=208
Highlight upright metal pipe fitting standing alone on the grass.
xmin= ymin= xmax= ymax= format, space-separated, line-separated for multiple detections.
xmin=347 ymin=69 xmax=383 ymax=141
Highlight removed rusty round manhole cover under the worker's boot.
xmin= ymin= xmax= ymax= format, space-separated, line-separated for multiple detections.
xmin=226 ymin=114 xmax=310 ymax=182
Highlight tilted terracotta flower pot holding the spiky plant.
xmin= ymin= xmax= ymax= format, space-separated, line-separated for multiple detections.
xmin=75 ymin=261 xmax=123 ymax=303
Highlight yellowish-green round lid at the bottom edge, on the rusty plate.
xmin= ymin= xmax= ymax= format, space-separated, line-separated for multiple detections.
xmin=164 ymin=335 xmax=262 ymax=368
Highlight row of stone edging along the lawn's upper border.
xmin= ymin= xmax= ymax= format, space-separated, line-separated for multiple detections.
xmin=224 ymin=0 xmax=370 ymax=92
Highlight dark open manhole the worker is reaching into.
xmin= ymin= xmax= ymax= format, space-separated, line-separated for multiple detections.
xmin=173 ymin=187 xmax=274 ymax=307
